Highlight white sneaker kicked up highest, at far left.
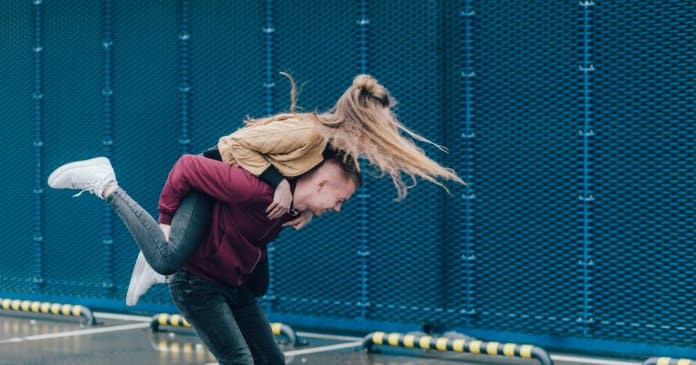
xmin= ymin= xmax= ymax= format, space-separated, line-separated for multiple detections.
xmin=48 ymin=157 xmax=116 ymax=199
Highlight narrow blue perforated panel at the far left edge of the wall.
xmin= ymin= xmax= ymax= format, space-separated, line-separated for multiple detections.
xmin=0 ymin=2 xmax=36 ymax=291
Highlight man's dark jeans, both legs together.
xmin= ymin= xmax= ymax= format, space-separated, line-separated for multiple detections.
xmin=169 ymin=270 xmax=285 ymax=365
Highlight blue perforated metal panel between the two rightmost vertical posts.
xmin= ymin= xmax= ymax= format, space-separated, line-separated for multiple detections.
xmin=469 ymin=2 xmax=582 ymax=333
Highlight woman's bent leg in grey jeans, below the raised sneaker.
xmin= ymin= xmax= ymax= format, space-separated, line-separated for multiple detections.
xmin=106 ymin=187 xmax=213 ymax=275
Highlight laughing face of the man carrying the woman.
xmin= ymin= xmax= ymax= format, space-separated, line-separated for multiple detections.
xmin=302 ymin=176 xmax=355 ymax=216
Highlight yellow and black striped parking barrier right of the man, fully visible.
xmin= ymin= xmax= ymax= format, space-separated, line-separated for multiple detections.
xmin=363 ymin=332 xmax=553 ymax=365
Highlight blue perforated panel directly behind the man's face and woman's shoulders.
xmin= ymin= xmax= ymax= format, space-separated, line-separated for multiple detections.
xmin=269 ymin=1 xmax=360 ymax=318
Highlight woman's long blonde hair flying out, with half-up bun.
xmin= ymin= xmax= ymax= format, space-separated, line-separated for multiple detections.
xmin=246 ymin=73 xmax=464 ymax=200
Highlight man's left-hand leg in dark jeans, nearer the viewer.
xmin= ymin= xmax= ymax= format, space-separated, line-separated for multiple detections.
xmin=169 ymin=271 xmax=256 ymax=365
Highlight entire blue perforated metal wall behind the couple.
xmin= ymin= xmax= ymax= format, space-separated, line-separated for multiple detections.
xmin=0 ymin=0 xmax=696 ymax=357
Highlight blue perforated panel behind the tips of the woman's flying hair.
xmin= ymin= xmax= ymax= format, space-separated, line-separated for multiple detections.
xmin=367 ymin=1 xmax=448 ymax=324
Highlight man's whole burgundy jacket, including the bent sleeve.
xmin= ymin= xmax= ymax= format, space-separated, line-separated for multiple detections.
xmin=158 ymin=155 xmax=292 ymax=286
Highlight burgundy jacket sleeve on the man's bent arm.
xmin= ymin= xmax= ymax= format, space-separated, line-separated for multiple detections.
xmin=158 ymin=155 xmax=268 ymax=224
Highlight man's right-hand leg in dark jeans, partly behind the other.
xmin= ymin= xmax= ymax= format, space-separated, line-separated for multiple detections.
xmin=231 ymin=287 xmax=285 ymax=365
